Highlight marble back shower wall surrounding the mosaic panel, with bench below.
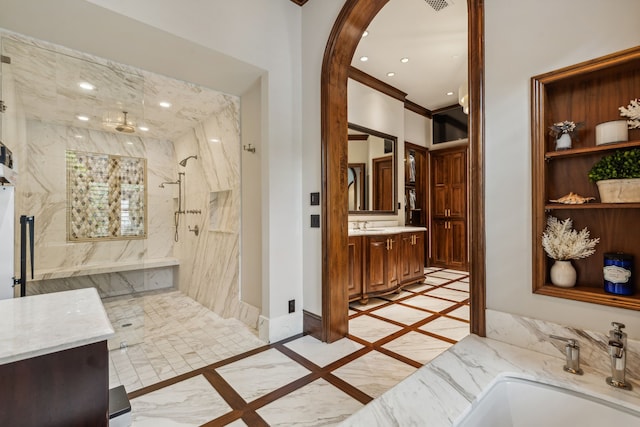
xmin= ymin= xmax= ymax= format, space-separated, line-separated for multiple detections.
xmin=16 ymin=120 xmax=176 ymax=297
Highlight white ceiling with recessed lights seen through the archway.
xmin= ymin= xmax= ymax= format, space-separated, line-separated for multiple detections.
xmin=352 ymin=0 xmax=467 ymax=111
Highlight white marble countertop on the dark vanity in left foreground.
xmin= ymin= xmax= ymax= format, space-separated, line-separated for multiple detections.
xmin=0 ymin=288 xmax=114 ymax=365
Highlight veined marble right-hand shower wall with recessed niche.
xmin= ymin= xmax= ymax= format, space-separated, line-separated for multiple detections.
xmin=175 ymin=102 xmax=259 ymax=328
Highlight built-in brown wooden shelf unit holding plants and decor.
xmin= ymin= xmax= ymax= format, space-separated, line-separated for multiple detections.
xmin=531 ymin=48 xmax=640 ymax=310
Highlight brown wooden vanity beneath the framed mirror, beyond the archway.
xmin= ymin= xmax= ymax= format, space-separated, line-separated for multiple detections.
xmin=348 ymin=227 xmax=426 ymax=304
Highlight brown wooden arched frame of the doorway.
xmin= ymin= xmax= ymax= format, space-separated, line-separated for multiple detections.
xmin=321 ymin=0 xmax=485 ymax=342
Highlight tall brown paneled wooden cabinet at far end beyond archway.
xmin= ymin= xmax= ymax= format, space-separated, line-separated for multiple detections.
xmin=429 ymin=146 xmax=468 ymax=270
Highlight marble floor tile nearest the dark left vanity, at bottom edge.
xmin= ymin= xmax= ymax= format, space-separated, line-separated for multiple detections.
xmin=131 ymin=375 xmax=231 ymax=427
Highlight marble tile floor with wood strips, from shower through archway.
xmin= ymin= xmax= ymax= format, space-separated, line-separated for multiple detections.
xmin=105 ymin=268 xmax=469 ymax=427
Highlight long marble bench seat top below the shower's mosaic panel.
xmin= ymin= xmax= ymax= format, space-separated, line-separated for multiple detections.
xmin=33 ymin=257 xmax=180 ymax=281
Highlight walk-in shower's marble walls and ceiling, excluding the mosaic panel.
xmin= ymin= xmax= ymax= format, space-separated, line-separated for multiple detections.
xmin=0 ymin=33 xmax=259 ymax=327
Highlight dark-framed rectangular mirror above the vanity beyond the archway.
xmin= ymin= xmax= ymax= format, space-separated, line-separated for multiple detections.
xmin=347 ymin=123 xmax=398 ymax=215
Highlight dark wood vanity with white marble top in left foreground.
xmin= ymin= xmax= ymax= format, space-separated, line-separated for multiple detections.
xmin=0 ymin=288 xmax=113 ymax=427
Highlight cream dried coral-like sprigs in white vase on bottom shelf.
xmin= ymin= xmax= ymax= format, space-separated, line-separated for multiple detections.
xmin=542 ymin=215 xmax=600 ymax=261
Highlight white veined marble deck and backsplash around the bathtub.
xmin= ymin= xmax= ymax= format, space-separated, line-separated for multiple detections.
xmin=340 ymin=335 xmax=640 ymax=427
